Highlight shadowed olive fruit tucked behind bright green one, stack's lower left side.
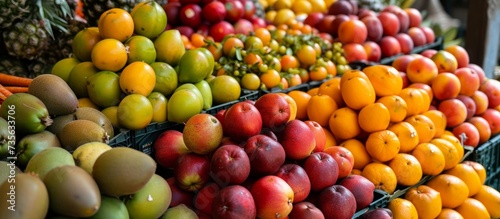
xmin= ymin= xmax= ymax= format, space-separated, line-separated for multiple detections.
xmin=68 ymin=61 xmax=99 ymax=98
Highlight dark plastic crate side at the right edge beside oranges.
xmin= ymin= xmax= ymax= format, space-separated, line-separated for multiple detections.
xmin=468 ymin=135 xmax=500 ymax=190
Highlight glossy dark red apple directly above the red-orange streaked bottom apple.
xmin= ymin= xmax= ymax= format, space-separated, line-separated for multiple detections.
xmin=244 ymin=135 xmax=286 ymax=176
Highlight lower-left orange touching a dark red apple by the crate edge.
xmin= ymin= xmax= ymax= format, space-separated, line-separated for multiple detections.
xmin=361 ymin=163 xmax=398 ymax=194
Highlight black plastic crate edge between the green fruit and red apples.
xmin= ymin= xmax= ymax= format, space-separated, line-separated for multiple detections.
xmin=108 ymin=90 xmax=259 ymax=156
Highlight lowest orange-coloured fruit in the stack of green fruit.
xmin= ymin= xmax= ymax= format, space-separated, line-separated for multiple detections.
xmin=119 ymin=62 xmax=156 ymax=96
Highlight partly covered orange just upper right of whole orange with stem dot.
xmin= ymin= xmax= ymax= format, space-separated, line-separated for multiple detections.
xmin=387 ymin=122 xmax=419 ymax=153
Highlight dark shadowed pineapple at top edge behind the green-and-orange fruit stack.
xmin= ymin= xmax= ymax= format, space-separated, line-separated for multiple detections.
xmin=82 ymin=0 xmax=146 ymax=27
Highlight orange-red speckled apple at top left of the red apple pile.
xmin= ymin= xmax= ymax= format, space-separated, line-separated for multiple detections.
xmin=182 ymin=113 xmax=223 ymax=154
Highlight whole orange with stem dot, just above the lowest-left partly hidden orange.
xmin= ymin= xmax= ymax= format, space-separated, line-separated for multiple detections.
xmin=365 ymin=130 xmax=400 ymax=162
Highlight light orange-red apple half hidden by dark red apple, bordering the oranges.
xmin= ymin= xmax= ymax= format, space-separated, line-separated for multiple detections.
xmin=324 ymin=146 xmax=354 ymax=179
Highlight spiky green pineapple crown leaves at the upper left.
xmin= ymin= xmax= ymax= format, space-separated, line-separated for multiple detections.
xmin=35 ymin=0 xmax=73 ymax=39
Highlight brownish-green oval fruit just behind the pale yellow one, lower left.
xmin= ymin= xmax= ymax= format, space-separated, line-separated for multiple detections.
xmin=59 ymin=119 xmax=109 ymax=151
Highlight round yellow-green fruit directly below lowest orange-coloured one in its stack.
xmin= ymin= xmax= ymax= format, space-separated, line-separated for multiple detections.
xmin=117 ymin=94 xmax=153 ymax=130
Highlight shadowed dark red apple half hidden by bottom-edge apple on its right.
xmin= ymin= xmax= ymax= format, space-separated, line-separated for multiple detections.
xmin=193 ymin=182 xmax=221 ymax=215
